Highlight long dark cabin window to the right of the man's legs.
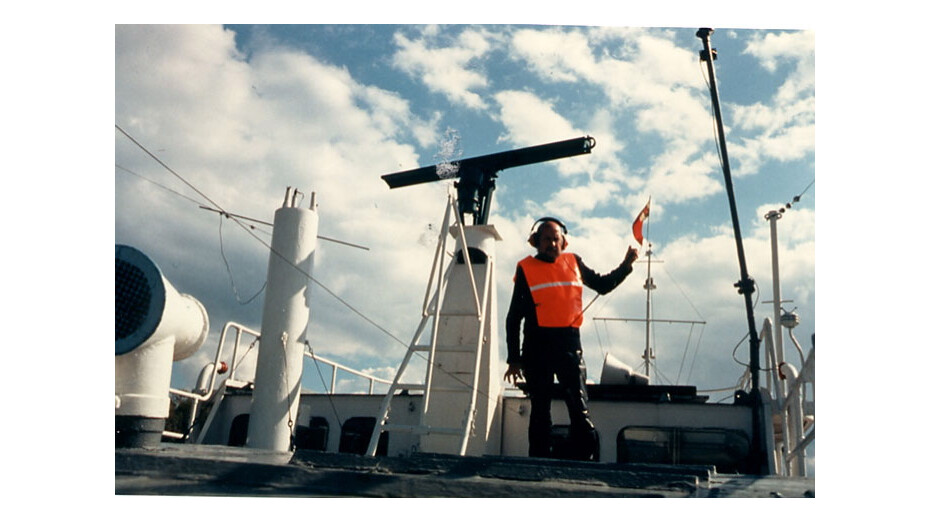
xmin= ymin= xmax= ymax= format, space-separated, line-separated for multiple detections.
xmin=617 ymin=427 xmax=749 ymax=473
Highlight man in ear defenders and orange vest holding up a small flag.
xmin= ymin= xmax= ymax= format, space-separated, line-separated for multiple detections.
xmin=504 ymin=217 xmax=639 ymax=460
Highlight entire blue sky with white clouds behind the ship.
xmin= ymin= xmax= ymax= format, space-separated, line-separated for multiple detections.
xmin=114 ymin=25 xmax=817 ymax=404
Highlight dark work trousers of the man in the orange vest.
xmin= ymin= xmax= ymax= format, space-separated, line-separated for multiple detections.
xmin=523 ymin=346 xmax=596 ymax=460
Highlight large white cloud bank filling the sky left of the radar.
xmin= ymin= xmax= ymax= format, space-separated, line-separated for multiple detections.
xmin=116 ymin=26 xmax=460 ymax=390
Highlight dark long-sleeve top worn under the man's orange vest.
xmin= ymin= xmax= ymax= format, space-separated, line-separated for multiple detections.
xmin=506 ymin=254 xmax=633 ymax=364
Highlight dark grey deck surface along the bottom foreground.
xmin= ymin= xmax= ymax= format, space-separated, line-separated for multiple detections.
xmin=115 ymin=444 xmax=814 ymax=498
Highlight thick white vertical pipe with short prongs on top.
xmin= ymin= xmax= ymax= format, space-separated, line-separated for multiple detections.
xmin=246 ymin=189 xmax=319 ymax=451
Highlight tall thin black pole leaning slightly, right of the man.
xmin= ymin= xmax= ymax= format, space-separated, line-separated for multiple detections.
xmin=697 ymin=28 xmax=768 ymax=474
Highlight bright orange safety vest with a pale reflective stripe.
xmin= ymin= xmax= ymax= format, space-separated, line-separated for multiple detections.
xmin=517 ymin=253 xmax=583 ymax=328
